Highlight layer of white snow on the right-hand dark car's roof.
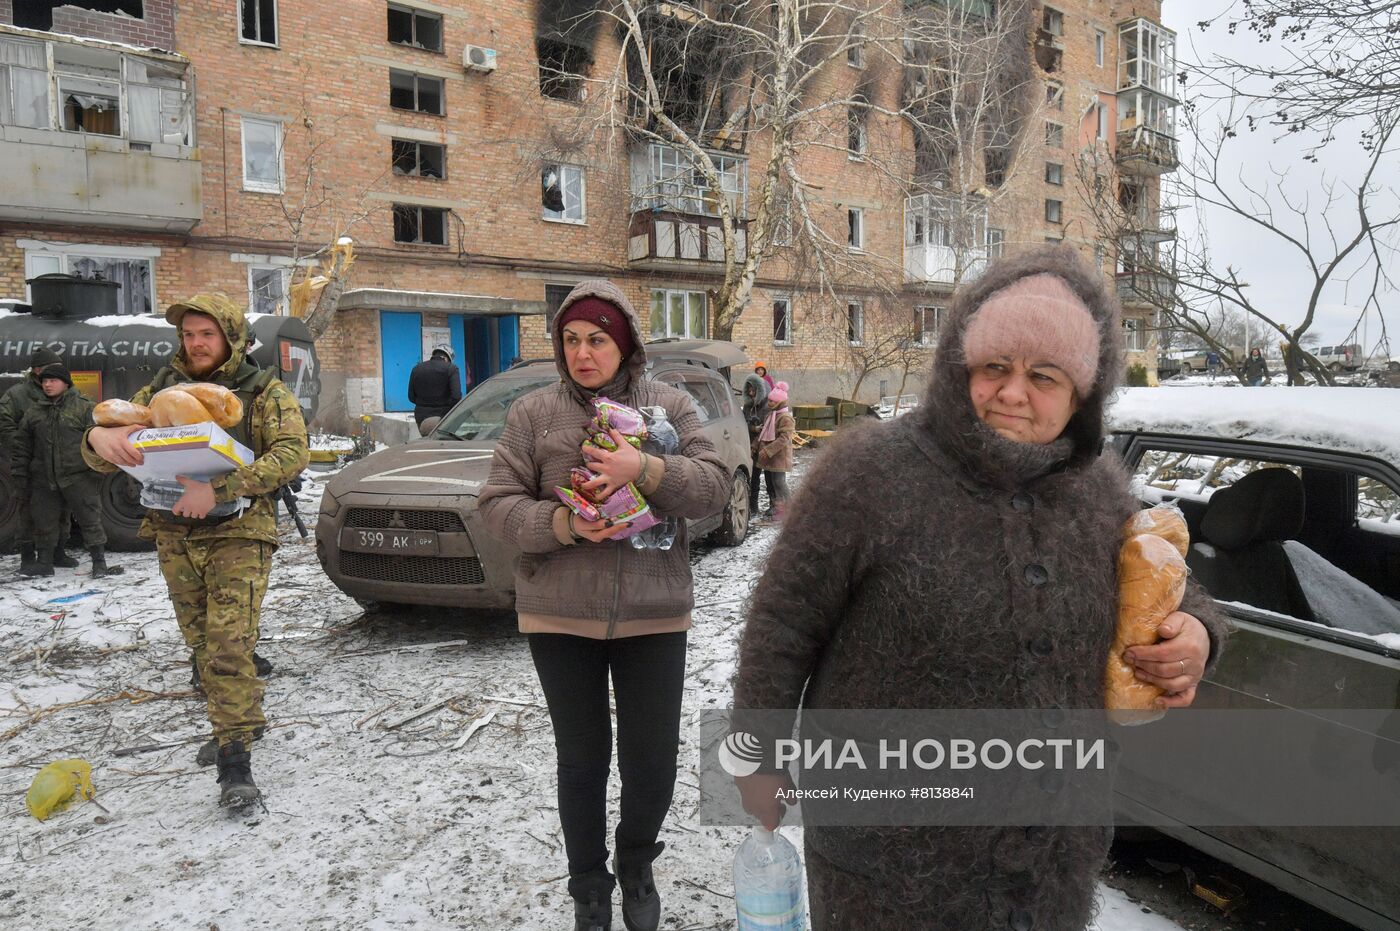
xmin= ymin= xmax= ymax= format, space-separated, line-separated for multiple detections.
xmin=1109 ymin=388 xmax=1400 ymax=463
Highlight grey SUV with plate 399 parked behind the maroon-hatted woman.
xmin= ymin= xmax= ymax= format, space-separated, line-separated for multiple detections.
xmin=316 ymin=340 xmax=753 ymax=608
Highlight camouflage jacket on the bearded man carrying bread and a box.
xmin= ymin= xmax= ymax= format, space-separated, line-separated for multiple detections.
xmin=83 ymin=298 xmax=311 ymax=546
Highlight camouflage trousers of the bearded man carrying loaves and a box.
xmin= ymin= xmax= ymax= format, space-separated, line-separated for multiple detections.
xmin=155 ymin=531 xmax=273 ymax=746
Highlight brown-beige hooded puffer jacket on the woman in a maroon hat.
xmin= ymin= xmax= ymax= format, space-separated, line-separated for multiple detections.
xmin=477 ymin=280 xmax=731 ymax=638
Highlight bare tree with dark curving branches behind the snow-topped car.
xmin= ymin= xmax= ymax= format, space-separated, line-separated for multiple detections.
xmin=1078 ymin=111 xmax=1400 ymax=385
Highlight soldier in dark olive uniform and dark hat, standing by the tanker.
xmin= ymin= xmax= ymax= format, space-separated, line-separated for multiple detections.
xmin=10 ymin=363 xmax=122 ymax=577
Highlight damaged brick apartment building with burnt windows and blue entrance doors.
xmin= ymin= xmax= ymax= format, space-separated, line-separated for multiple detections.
xmin=0 ymin=0 xmax=1176 ymax=428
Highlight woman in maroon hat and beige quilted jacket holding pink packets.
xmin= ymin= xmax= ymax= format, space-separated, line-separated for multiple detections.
xmin=479 ymin=280 xmax=729 ymax=931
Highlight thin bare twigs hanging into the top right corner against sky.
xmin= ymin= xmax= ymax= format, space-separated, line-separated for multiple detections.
xmin=1198 ymin=0 xmax=1400 ymax=148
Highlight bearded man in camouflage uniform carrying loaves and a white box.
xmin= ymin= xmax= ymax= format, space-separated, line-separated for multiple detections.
xmin=83 ymin=294 xmax=309 ymax=806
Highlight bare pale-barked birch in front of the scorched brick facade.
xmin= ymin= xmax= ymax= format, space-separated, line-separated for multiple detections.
xmin=521 ymin=0 xmax=1036 ymax=348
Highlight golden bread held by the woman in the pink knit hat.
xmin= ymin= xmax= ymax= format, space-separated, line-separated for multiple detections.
xmin=1105 ymin=507 xmax=1190 ymax=724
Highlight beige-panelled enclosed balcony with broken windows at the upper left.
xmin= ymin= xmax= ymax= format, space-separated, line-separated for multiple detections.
xmin=0 ymin=25 xmax=203 ymax=232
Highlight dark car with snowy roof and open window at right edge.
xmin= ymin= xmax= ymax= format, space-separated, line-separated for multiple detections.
xmin=1110 ymin=388 xmax=1400 ymax=931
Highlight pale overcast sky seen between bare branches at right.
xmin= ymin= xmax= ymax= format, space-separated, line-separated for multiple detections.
xmin=1162 ymin=0 xmax=1400 ymax=356
